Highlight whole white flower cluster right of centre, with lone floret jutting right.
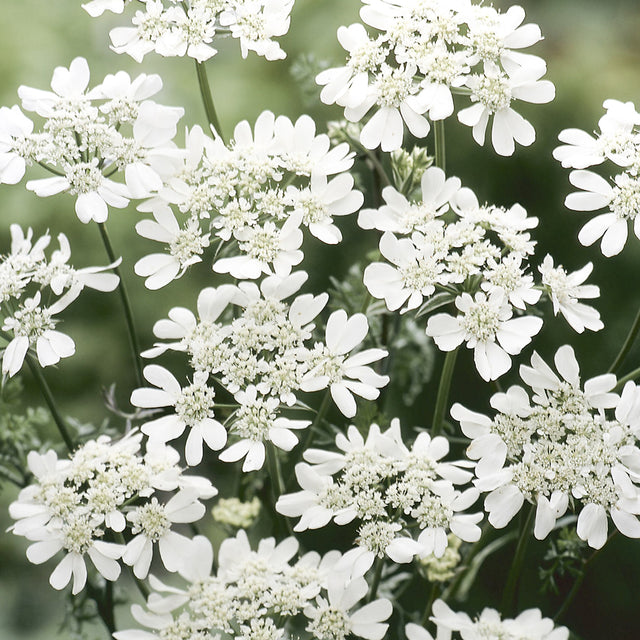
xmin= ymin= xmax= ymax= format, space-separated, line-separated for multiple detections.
xmin=358 ymin=167 xmax=604 ymax=380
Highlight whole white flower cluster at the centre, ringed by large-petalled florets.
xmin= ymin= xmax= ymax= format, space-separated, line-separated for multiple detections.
xmin=131 ymin=271 xmax=389 ymax=471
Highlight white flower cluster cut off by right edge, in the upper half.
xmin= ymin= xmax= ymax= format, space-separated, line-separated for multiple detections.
xmin=553 ymin=100 xmax=640 ymax=257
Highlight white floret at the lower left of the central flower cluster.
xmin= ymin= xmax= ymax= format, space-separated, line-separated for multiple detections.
xmin=131 ymin=365 xmax=227 ymax=466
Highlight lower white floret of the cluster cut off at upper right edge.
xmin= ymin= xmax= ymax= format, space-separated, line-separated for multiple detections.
xmin=565 ymin=170 xmax=640 ymax=258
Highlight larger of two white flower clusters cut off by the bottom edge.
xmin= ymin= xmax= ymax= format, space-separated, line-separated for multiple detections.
xmin=113 ymin=530 xmax=392 ymax=640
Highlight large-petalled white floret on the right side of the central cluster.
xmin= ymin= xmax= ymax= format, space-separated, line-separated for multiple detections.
xmin=301 ymin=309 xmax=389 ymax=418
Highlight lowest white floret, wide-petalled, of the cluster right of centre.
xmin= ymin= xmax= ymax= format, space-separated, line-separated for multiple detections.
xmin=427 ymin=290 xmax=542 ymax=380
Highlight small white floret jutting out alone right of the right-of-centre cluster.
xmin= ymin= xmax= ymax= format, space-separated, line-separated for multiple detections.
xmin=540 ymin=256 xmax=604 ymax=333
